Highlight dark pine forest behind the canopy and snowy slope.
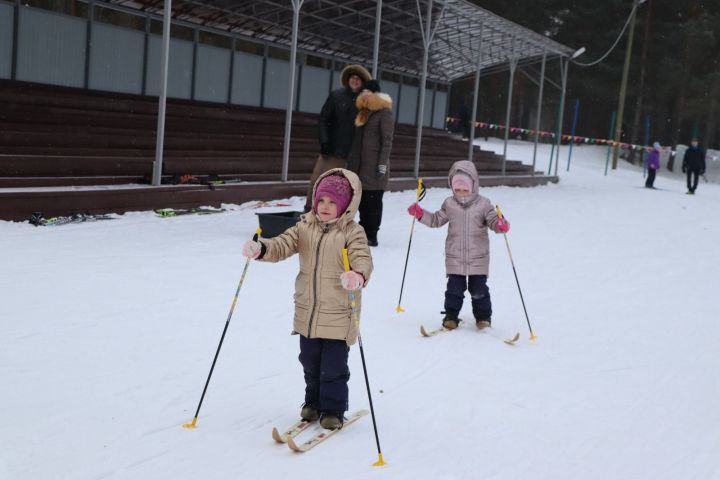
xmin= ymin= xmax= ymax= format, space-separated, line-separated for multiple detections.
xmin=450 ymin=0 xmax=720 ymax=158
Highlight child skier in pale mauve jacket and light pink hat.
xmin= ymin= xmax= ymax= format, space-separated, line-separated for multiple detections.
xmin=408 ymin=160 xmax=510 ymax=330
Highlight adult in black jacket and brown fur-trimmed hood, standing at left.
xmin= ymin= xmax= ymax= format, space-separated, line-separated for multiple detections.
xmin=305 ymin=65 xmax=371 ymax=212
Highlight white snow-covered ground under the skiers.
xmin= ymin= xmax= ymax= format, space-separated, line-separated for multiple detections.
xmin=0 ymin=141 xmax=720 ymax=480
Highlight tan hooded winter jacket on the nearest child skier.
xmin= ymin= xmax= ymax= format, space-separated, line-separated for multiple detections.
xmin=260 ymin=168 xmax=373 ymax=345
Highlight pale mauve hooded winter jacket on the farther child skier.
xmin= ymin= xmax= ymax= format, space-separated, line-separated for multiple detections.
xmin=420 ymin=160 xmax=499 ymax=275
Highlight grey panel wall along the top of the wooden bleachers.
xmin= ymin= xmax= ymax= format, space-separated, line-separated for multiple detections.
xmin=0 ymin=0 xmax=447 ymax=128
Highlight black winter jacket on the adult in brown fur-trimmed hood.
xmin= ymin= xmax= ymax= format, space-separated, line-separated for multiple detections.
xmin=318 ymin=87 xmax=358 ymax=158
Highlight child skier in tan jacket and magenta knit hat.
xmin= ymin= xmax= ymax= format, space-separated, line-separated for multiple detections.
xmin=243 ymin=168 xmax=373 ymax=429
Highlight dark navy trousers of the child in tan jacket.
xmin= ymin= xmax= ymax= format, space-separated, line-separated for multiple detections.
xmin=298 ymin=335 xmax=350 ymax=413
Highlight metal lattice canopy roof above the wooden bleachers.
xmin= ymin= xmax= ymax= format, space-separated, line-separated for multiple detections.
xmin=105 ymin=0 xmax=574 ymax=82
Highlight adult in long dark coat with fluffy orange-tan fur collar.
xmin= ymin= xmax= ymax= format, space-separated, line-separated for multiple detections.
xmin=348 ymin=80 xmax=395 ymax=247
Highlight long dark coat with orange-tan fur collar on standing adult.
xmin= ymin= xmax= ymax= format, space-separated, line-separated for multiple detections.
xmin=348 ymin=93 xmax=395 ymax=190
